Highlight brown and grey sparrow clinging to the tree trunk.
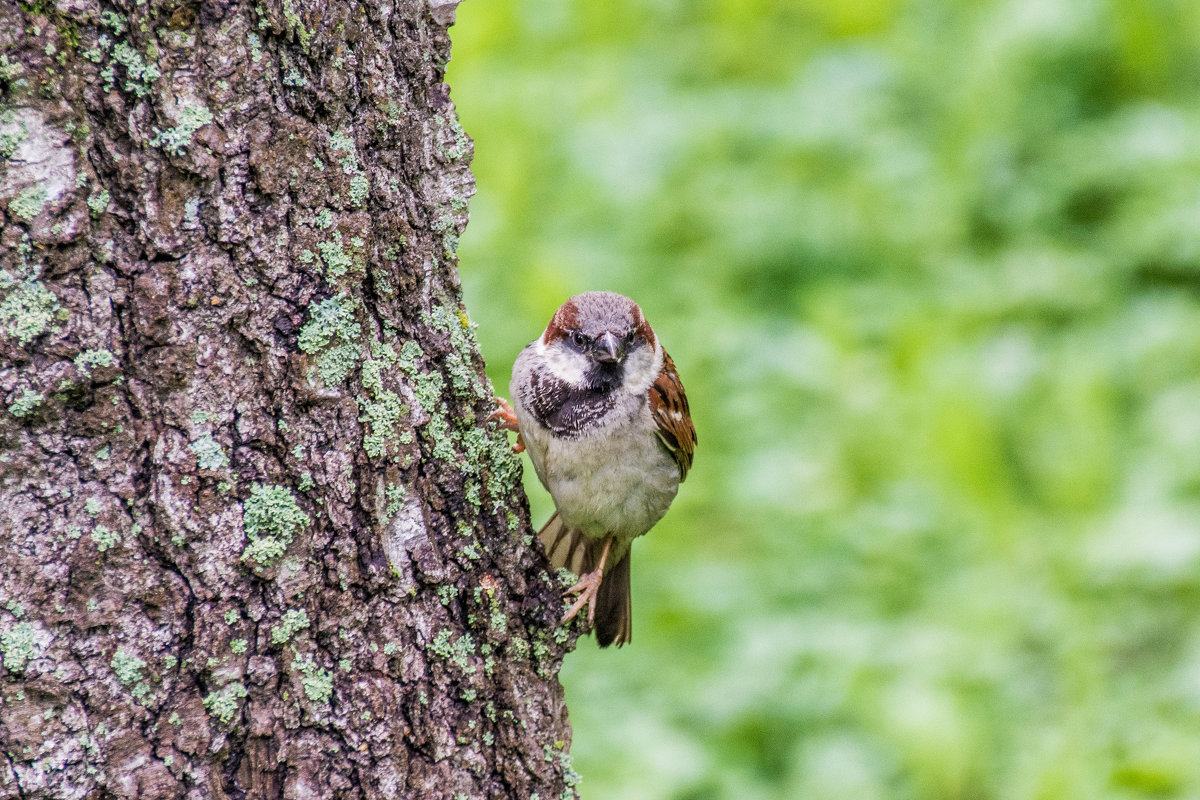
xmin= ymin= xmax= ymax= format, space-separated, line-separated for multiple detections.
xmin=492 ymin=291 xmax=696 ymax=648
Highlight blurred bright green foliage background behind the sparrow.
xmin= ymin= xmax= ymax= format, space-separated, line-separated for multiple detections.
xmin=449 ymin=0 xmax=1200 ymax=800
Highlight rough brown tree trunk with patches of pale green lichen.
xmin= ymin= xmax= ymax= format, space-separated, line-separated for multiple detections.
xmin=0 ymin=0 xmax=575 ymax=800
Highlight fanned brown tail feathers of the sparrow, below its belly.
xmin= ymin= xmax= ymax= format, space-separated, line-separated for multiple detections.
xmin=538 ymin=511 xmax=634 ymax=648
